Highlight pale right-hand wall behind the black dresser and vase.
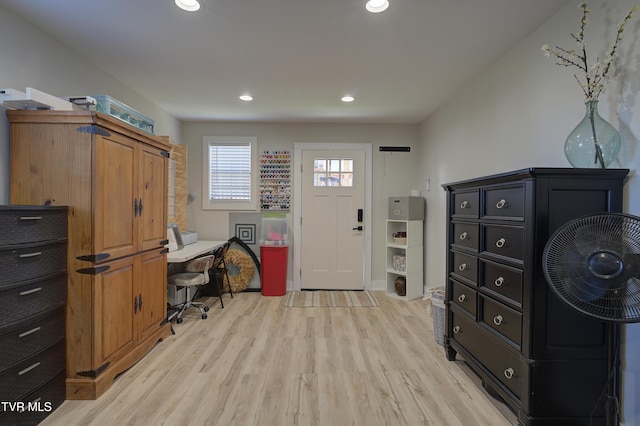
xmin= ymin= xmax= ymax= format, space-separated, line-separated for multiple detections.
xmin=419 ymin=0 xmax=640 ymax=425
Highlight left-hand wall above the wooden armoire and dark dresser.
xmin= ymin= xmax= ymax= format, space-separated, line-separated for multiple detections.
xmin=0 ymin=6 xmax=180 ymax=204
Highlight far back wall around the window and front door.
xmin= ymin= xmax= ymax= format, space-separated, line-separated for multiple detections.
xmin=181 ymin=122 xmax=419 ymax=289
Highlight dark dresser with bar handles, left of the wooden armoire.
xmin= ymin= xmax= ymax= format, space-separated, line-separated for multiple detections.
xmin=0 ymin=206 xmax=67 ymax=425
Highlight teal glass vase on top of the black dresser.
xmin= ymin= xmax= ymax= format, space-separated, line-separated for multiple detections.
xmin=564 ymin=101 xmax=622 ymax=169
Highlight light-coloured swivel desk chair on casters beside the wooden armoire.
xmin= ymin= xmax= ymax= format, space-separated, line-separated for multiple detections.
xmin=167 ymin=255 xmax=214 ymax=324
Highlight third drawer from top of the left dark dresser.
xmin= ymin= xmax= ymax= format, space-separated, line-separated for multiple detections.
xmin=0 ymin=274 xmax=67 ymax=327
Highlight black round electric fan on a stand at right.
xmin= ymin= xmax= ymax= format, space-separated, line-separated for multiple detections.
xmin=542 ymin=213 xmax=640 ymax=425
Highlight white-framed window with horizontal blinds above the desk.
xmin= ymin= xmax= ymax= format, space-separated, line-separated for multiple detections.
xmin=203 ymin=136 xmax=256 ymax=210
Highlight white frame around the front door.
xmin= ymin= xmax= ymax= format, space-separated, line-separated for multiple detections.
xmin=291 ymin=143 xmax=373 ymax=291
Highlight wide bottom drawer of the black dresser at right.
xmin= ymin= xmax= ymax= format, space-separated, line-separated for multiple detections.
xmin=451 ymin=310 xmax=526 ymax=399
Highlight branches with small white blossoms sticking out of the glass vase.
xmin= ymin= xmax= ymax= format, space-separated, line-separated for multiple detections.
xmin=542 ymin=3 xmax=638 ymax=101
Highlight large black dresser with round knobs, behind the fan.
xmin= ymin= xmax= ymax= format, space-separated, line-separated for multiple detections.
xmin=443 ymin=168 xmax=629 ymax=425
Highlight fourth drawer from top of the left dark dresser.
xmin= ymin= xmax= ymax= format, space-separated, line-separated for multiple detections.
xmin=0 ymin=307 xmax=65 ymax=370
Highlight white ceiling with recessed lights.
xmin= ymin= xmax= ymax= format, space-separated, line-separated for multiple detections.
xmin=0 ymin=0 xmax=567 ymax=123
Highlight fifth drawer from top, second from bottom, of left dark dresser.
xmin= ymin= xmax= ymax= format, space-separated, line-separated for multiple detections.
xmin=0 ymin=340 xmax=65 ymax=401
